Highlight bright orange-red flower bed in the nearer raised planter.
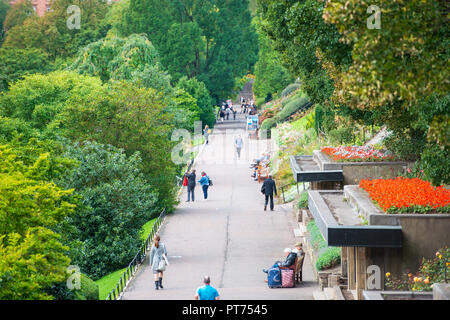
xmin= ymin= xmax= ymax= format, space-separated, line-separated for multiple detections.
xmin=359 ymin=177 xmax=450 ymax=213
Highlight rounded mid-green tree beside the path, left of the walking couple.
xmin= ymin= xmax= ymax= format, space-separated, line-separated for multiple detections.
xmin=58 ymin=81 xmax=176 ymax=208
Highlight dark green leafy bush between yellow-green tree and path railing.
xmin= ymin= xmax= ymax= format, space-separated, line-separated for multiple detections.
xmin=60 ymin=142 xmax=158 ymax=279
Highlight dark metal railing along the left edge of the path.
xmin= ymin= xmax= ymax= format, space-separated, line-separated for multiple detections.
xmin=106 ymin=209 xmax=166 ymax=300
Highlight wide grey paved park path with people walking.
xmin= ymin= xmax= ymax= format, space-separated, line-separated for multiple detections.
xmin=123 ymin=115 xmax=317 ymax=300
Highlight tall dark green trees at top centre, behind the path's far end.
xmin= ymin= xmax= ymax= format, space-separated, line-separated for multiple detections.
xmin=118 ymin=0 xmax=257 ymax=101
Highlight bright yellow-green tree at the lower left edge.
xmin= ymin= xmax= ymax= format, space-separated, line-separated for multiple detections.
xmin=0 ymin=145 xmax=74 ymax=300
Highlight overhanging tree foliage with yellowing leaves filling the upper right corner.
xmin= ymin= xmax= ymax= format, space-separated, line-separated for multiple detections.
xmin=258 ymin=0 xmax=450 ymax=184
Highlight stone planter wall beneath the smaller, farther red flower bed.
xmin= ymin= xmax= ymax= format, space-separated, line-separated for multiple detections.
xmin=313 ymin=150 xmax=408 ymax=185
